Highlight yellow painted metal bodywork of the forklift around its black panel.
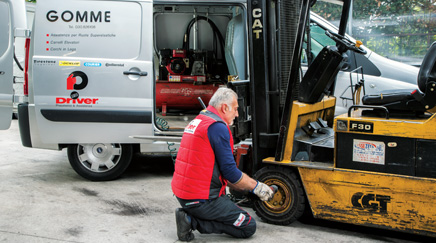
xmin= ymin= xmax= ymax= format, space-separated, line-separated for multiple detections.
xmin=263 ymin=98 xmax=436 ymax=237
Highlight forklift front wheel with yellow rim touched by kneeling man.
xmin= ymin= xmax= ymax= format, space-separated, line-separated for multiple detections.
xmin=253 ymin=166 xmax=306 ymax=225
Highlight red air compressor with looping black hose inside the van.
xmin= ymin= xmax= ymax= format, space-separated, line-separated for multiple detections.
xmin=156 ymin=16 xmax=228 ymax=115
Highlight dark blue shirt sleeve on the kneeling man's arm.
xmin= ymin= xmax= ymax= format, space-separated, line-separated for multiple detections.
xmin=207 ymin=122 xmax=242 ymax=184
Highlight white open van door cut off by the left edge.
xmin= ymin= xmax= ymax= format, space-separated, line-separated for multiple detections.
xmin=0 ymin=0 xmax=26 ymax=130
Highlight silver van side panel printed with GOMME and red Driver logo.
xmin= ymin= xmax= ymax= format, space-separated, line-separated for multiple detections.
xmin=29 ymin=0 xmax=154 ymax=147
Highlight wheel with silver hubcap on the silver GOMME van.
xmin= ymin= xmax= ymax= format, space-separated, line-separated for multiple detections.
xmin=68 ymin=143 xmax=133 ymax=181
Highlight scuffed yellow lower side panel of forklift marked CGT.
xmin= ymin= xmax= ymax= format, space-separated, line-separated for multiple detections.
xmin=298 ymin=167 xmax=436 ymax=236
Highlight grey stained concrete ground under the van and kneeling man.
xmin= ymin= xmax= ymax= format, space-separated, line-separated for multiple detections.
xmin=0 ymin=120 xmax=434 ymax=243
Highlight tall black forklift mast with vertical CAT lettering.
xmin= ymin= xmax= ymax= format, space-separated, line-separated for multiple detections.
xmin=248 ymin=0 xmax=315 ymax=171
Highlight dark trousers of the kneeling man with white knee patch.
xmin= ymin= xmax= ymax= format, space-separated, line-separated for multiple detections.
xmin=178 ymin=195 xmax=256 ymax=238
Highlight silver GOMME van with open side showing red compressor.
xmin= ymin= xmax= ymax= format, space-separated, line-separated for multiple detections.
xmin=0 ymin=0 xmax=422 ymax=180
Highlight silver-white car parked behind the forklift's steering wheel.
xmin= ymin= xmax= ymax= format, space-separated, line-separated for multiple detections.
xmin=302 ymin=12 xmax=419 ymax=115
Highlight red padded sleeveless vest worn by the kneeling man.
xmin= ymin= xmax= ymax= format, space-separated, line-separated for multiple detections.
xmin=171 ymin=106 xmax=233 ymax=200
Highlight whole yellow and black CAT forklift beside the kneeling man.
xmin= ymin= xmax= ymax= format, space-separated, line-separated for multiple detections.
xmin=230 ymin=0 xmax=436 ymax=236
